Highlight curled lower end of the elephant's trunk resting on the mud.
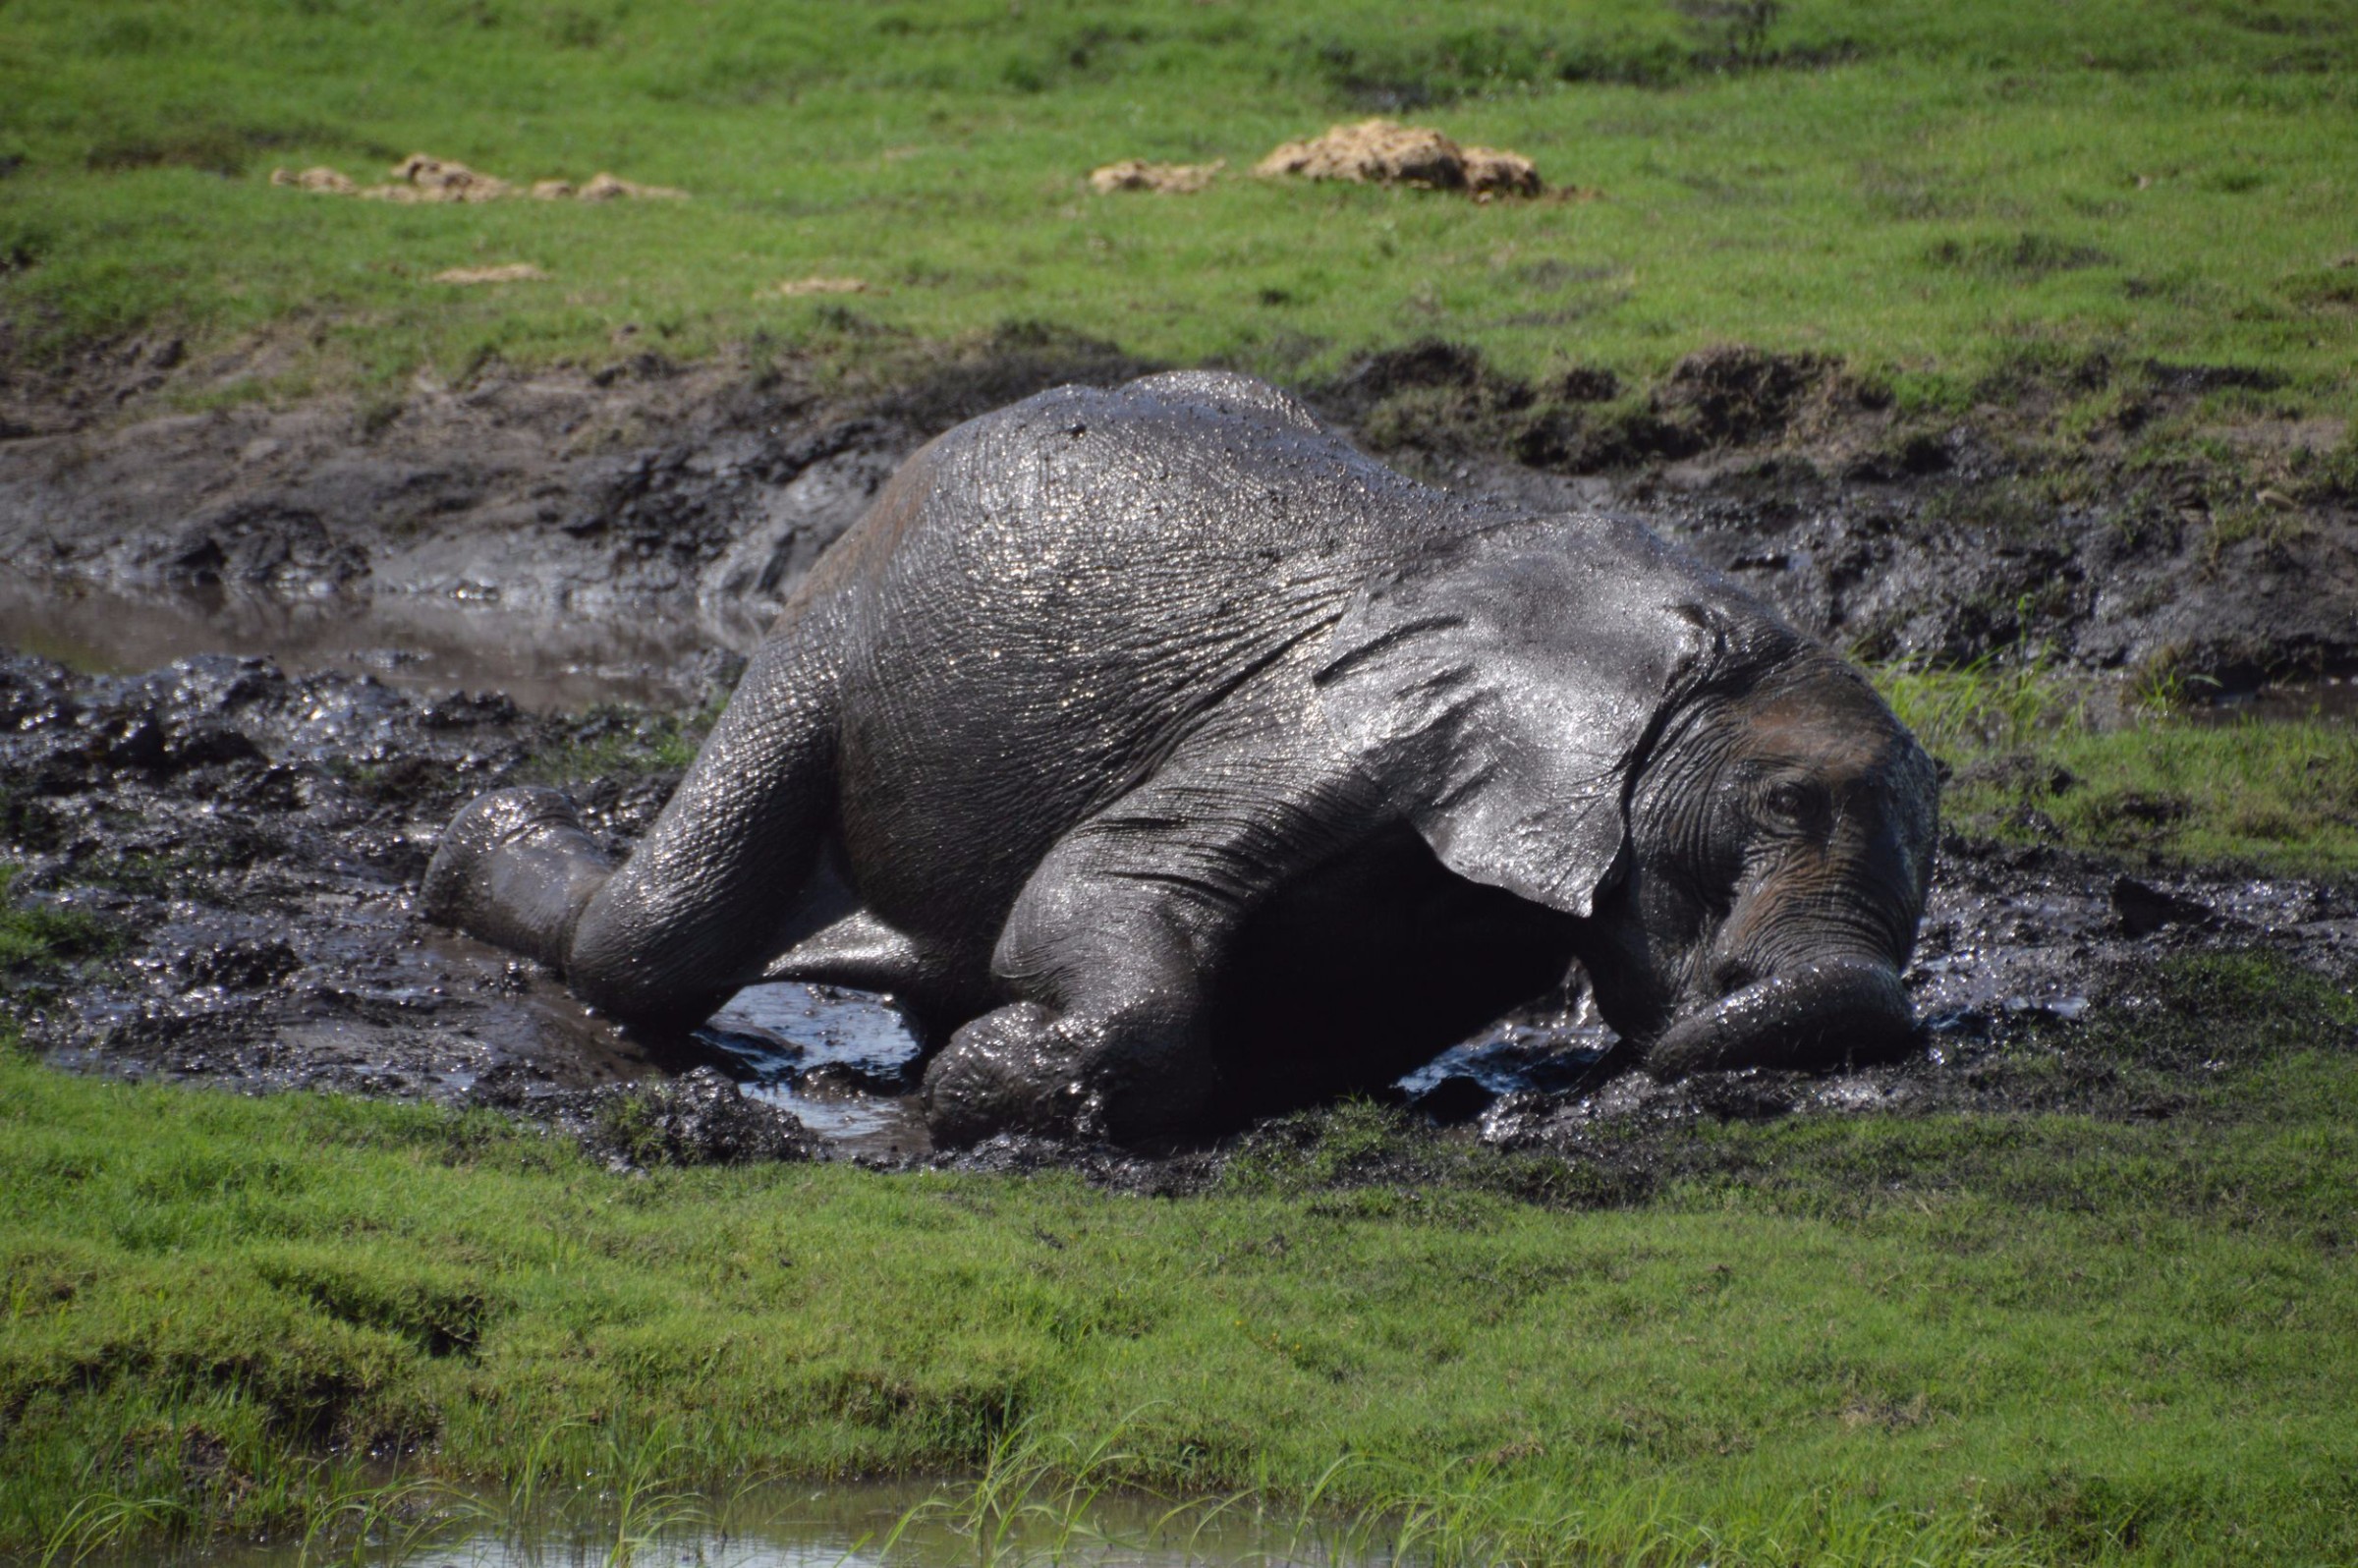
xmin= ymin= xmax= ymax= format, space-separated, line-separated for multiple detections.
xmin=1646 ymin=957 xmax=1915 ymax=1078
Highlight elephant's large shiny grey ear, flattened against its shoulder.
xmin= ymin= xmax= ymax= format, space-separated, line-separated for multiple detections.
xmin=1314 ymin=519 xmax=1792 ymax=918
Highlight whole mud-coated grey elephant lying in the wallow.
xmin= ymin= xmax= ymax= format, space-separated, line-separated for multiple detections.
xmin=424 ymin=372 xmax=1938 ymax=1144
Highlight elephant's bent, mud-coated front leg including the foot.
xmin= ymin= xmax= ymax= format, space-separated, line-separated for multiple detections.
xmin=925 ymin=736 xmax=1379 ymax=1146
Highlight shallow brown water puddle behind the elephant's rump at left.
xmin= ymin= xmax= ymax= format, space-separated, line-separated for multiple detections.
xmin=0 ymin=573 xmax=721 ymax=712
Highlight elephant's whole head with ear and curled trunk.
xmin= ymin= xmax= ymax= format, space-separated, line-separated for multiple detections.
xmin=1316 ymin=519 xmax=1938 ymax=1075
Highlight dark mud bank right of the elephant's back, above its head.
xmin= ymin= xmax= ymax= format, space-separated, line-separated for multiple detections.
xmin=1319 ymin=342 xmax=2358 ymax=698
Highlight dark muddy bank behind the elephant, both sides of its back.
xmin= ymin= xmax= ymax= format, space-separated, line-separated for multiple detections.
xmin=0 ymin=332 xmax=2358 ymax=694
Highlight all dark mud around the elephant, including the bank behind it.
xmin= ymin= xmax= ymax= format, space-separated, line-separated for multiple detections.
xmin=0 ymin=340 xmax=2358 ymax=1191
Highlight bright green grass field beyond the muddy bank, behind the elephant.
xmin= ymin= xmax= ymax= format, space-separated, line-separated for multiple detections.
xmin=0 ymin=0 xmax=2358 ymax=413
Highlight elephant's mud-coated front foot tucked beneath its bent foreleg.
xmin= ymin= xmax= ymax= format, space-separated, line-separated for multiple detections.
xmin=922 ymin=1002 xmax=1212 ymax=1148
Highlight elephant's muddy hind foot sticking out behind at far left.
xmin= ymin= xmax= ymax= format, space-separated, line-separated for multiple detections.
xmin=420 ymin=785 xmax=613 ymax=969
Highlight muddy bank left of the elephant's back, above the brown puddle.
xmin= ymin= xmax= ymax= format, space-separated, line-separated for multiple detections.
xmin=0 ymin=322 xmax=1142 ymax=648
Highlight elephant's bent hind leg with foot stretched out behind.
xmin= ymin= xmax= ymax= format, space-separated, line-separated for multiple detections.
xmin=424 ymin=630 xmax=837 ymax=1028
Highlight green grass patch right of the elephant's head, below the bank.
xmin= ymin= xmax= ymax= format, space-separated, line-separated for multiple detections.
xmin=1880 ymin=658 xmax=2358 ymax=877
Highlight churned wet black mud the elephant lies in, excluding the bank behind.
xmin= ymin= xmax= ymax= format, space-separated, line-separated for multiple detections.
xmin=0 ymin=655 xmax=2358 ymax=1189
